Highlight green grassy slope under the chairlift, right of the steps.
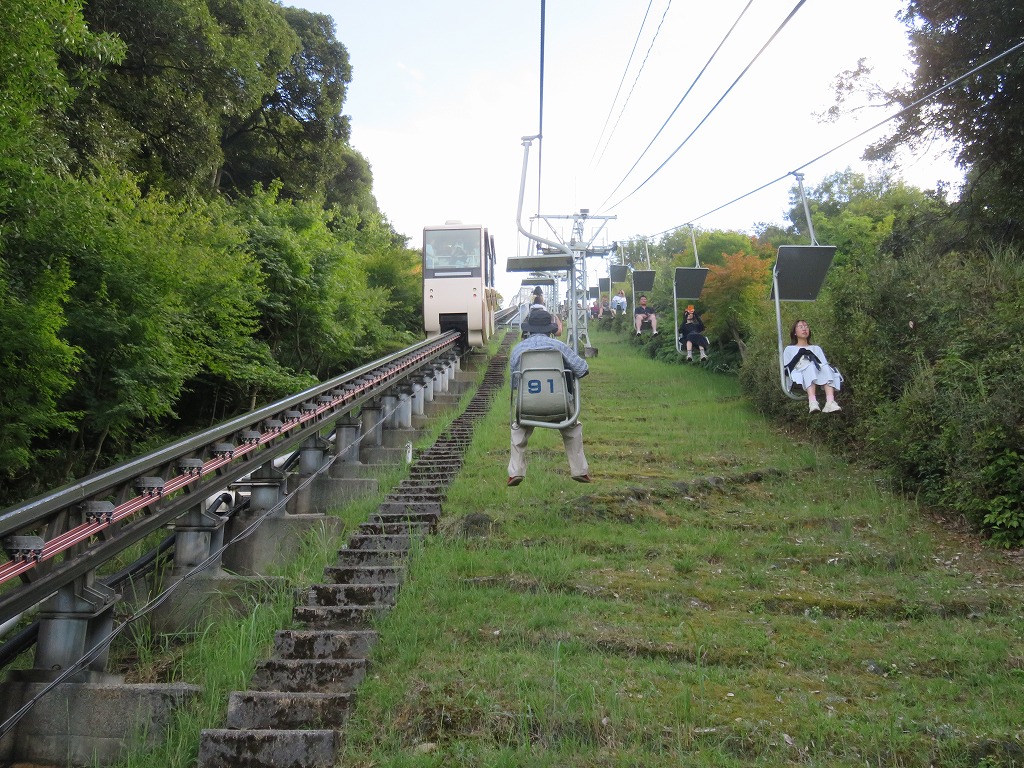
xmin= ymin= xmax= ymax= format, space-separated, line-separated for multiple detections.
xmin=343 ymin=325 xmax=1024 ymax=766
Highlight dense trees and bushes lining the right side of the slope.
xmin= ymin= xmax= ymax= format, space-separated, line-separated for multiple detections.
xmin=602 ymin=0 xmax=1024 ymax=546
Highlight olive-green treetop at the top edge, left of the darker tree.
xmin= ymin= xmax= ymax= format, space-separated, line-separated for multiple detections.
xmin=67 ymin=0 xmax=301 ymax=194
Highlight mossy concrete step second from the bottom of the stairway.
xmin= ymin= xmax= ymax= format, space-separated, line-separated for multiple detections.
xmin=226 ymin=690 xmax=355 ymax=730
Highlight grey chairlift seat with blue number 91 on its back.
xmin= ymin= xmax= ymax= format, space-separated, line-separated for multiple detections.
xmin=512 ymin=349 xmax=580 ymax=429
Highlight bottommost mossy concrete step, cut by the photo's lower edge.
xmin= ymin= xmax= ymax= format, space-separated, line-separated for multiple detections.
xmin=199 ymin=728 xmax=339 ymax=768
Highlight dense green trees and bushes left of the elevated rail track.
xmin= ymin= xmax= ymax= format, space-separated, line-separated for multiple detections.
xmin=0 ymin=0 xmax=420 ymax=503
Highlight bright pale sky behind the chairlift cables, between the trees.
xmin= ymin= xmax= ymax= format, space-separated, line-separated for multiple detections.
xmin=284 ymin=0 xmax=962 ymax=305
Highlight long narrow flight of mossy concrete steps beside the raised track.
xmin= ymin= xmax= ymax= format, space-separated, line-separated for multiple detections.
xmin=199 ymin=334 xmax=513 ymax=768
